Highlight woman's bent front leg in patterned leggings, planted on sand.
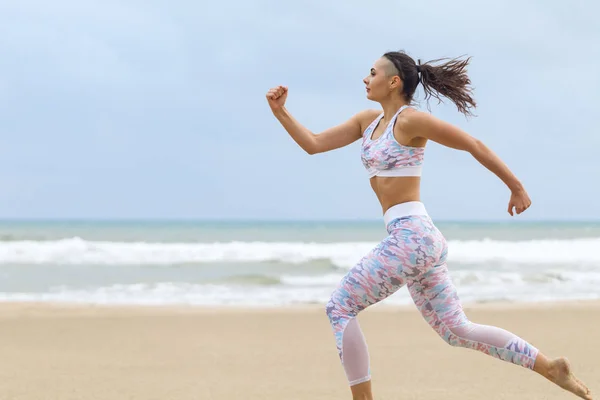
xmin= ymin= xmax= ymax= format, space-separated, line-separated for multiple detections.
xmin=326 ymin=217 xmax=444 ymax=400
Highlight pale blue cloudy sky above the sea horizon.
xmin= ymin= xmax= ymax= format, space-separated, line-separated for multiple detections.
xmin=0 ymin=0 xmax=600 ymax=221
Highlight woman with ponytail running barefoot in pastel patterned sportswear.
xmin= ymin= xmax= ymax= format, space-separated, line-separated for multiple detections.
xmin=267 ymin=52 xmax=592 ymax=400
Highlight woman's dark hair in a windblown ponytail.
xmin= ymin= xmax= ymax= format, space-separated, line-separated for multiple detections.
xmin=383 ymin=51 xmax=477 ymax=116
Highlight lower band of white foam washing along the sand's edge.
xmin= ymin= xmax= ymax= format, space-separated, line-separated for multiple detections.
xmin=0 ymin=279 xmax=600 ymax=307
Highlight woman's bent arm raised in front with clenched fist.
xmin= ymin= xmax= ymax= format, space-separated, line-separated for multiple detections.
xmin=267 ymin=86 xmax=371 ymax=154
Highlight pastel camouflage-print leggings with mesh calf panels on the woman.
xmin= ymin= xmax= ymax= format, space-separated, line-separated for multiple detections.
xmin=326 ymin=215 xmax=538 ymax=386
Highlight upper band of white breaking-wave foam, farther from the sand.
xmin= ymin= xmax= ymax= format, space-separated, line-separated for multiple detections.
xmin=0 ymin=238 xmax=600 ymax=269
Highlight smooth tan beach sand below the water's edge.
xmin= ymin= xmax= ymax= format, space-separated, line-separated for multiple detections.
xmin=0 ymin=302 xmax=600 ymax=400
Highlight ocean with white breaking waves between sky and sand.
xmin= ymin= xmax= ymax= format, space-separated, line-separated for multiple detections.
xmin=0 ymin=221 xmax=600 ymax=307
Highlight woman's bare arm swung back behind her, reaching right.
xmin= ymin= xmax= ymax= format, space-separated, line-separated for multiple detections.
xmin=403 ymin=112 xmax=531 ymax=215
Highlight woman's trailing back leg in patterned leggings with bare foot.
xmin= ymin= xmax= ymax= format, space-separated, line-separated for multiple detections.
xmin=408 ymin=259 xmax=592 ymax=400
